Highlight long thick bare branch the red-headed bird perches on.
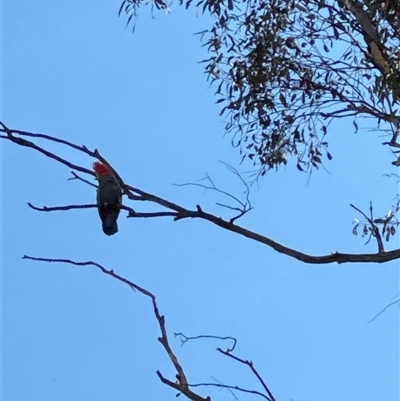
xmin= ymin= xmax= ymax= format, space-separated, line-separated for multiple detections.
xmin=0 ymin=124 xmax=400 ymax=264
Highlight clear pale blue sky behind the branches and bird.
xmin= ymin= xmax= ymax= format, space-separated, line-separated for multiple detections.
xmin=1 ymin=0 xmax=399 ymax=401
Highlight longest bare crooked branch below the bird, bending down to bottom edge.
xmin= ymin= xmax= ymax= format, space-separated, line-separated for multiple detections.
xmin=22 ymin=255 xmax=211 ymax=401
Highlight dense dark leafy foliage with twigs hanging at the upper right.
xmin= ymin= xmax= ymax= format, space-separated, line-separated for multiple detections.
xmin=120 ymin=0 xmax=400 ymax=175
